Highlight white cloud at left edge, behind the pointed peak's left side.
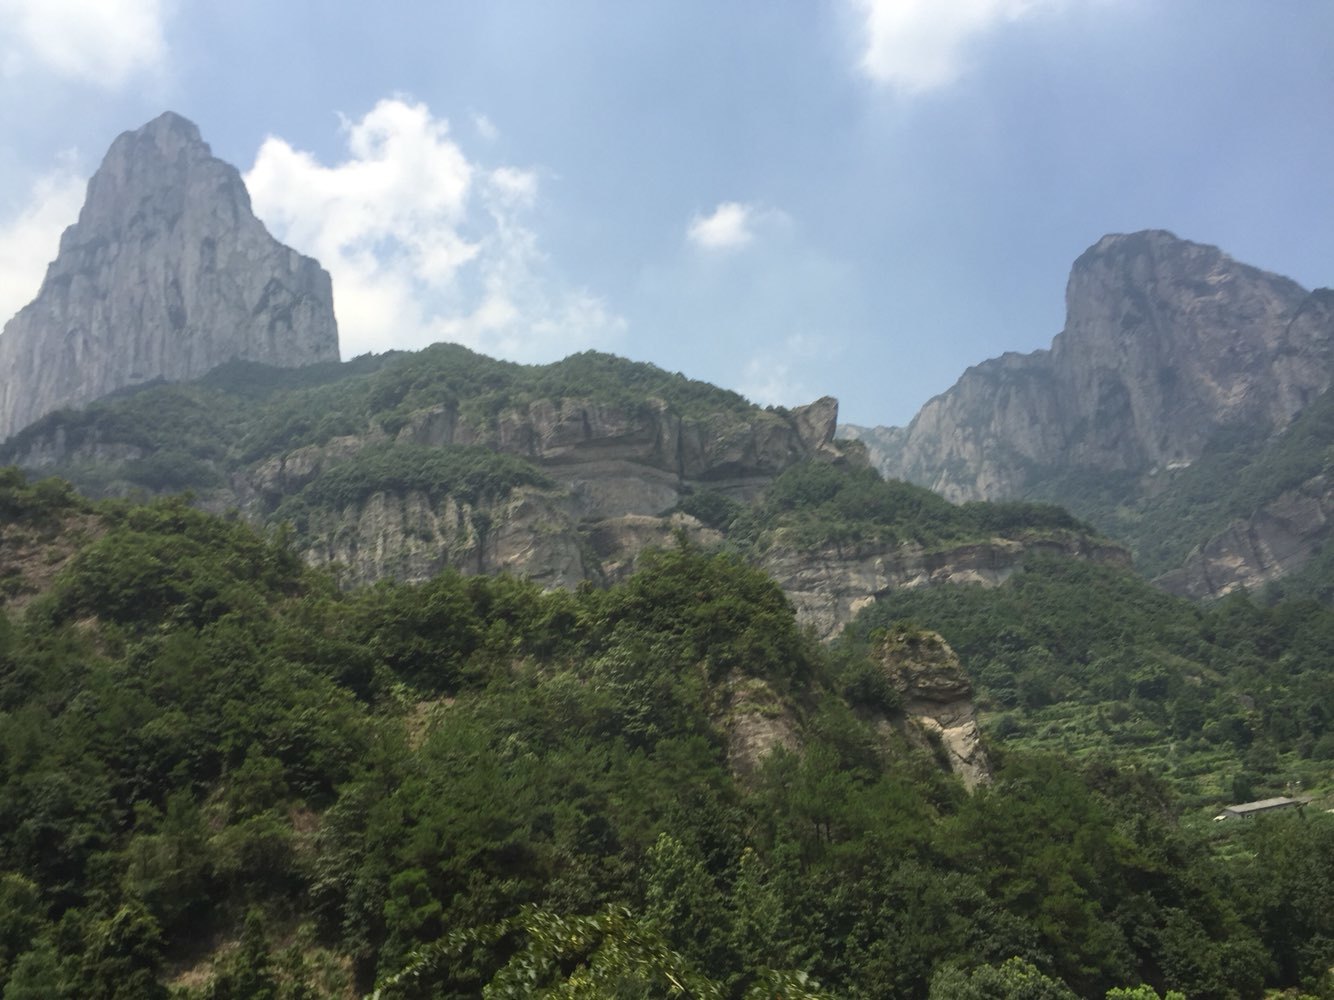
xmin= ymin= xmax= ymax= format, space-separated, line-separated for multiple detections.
xmin=0 ymin=153 xmax=88 ymax=325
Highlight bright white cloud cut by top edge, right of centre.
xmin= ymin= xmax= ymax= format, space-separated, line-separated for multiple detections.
xmin=852 ymin=0 xmax=1063 ymax=93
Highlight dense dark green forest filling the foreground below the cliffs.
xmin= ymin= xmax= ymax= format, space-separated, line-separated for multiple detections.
xmin=0 ymin=472 xmax=1334 ymax=1000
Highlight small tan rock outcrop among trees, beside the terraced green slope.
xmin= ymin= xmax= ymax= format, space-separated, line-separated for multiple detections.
xmin=875 ymin=632 xmax=991 ymax=789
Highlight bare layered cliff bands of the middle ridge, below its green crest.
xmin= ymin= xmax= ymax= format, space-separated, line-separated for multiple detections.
xmin=233 ymin=397 xmax=839 ymax=587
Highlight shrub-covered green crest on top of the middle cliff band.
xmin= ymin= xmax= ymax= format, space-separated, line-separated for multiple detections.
xmin=3 ymin=344 xmax=752 ymax=496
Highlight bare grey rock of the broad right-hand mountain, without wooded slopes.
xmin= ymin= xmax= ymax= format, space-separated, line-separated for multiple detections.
xmin=842 ymin=231 xmax=1334 ymax=501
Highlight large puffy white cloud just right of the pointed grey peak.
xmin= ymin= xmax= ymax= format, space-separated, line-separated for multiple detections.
xmin=245 ymin=99 xmax=624 ymax=361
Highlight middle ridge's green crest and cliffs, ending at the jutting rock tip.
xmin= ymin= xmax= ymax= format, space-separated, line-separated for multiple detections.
xmin=0 ymin=344 xmax=840 ymax=585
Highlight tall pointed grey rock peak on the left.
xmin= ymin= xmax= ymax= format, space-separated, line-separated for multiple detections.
xmin=0 ymin=112 xmax=338 ymax=440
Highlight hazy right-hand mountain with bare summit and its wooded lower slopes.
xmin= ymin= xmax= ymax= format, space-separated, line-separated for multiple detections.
xmin=840 ymin=231 xmax=1334 ymax=596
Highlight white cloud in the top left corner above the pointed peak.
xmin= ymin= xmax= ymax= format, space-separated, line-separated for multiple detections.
xmin=0 ymin=0 xmax=167 ymax=88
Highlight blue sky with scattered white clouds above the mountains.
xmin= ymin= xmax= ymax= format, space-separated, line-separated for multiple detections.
xmin=0 ymin=0 xmax=1334 ymax=425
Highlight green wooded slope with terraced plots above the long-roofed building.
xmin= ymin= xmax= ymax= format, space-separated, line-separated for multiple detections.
xmin=842 ymin=557 xmax=1334 ymax=809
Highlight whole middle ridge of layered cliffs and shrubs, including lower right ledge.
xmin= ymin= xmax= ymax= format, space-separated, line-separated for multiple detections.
xmin=0 ymin=344 xmax=1125 ymax=636
